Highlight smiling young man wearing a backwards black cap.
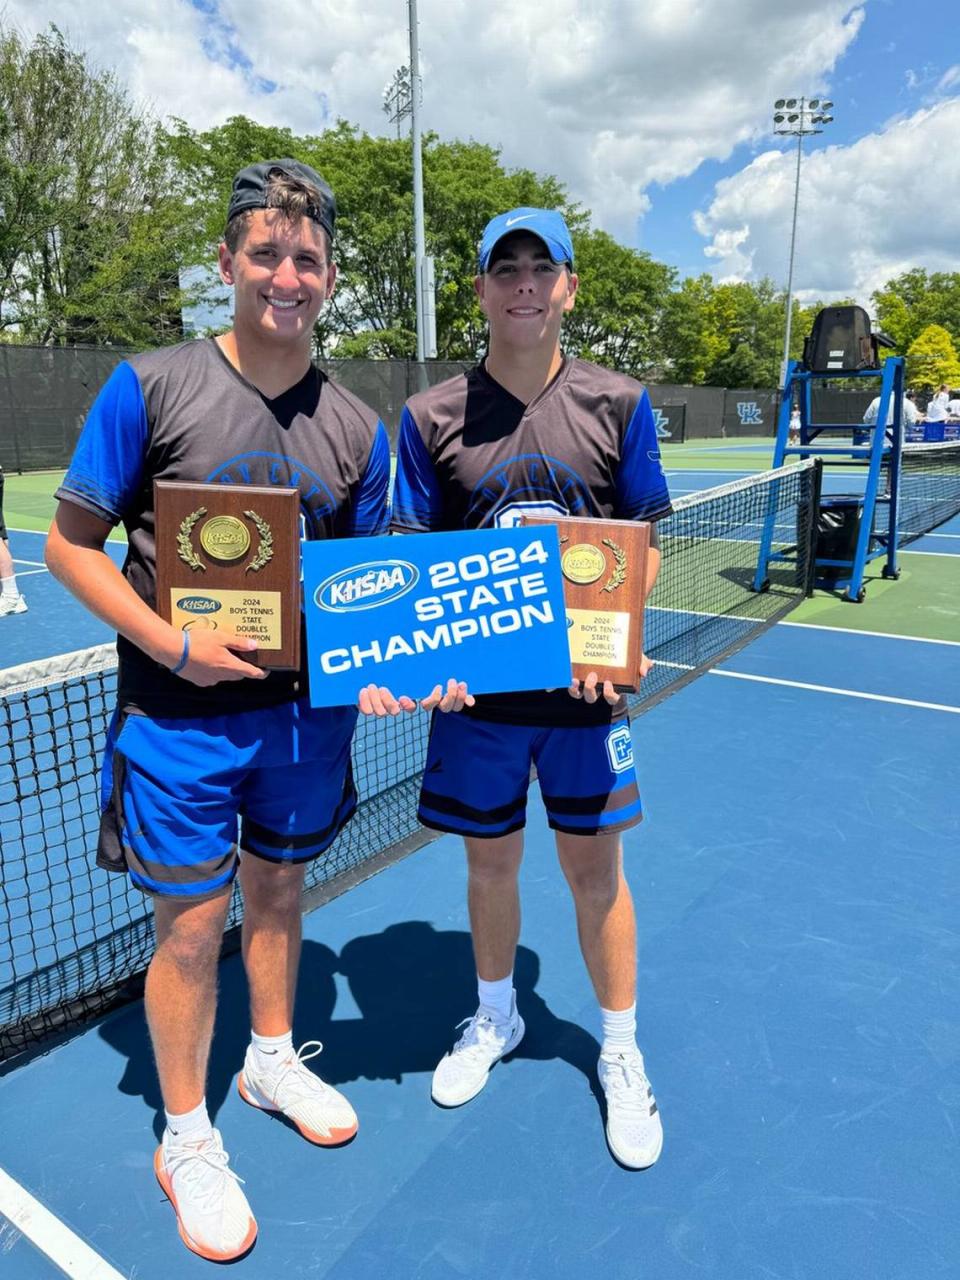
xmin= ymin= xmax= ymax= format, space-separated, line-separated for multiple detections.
xmin=47 ymin=160 xmax=399 ymax=1261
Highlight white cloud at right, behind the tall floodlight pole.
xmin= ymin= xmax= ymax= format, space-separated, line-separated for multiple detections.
xmin=695 ymin=97 xmax=960 ymax=302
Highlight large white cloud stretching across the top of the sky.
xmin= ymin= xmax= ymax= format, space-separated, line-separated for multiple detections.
xmin=5 ymin=0 xmax=863 ymax=243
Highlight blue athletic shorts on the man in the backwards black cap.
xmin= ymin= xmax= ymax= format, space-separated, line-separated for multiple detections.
xmin=97 ymin=700 xmax=357 ymax=900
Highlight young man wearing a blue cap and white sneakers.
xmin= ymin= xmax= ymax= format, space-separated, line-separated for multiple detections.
xmin=393 ymin=209 xmax=671 ymax=1169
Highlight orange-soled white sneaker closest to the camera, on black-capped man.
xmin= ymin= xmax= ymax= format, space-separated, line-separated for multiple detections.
xmin=154 ymin=1129 xmax=257 ymax=1262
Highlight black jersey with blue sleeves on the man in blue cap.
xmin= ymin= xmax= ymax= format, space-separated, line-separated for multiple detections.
xmin=393 ymin=360 xmax=671 ymax=726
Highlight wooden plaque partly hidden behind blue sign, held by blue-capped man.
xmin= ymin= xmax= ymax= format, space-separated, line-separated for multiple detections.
xmin=522 ymin=516 xmax=650 ymax=694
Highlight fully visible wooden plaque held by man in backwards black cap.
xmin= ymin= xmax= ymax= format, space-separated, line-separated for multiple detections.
xmin=154 ymin=480 xmax=301 ymax=671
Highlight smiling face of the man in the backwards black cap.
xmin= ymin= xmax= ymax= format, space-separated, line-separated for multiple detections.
xmin=220 ymin=209 xmax=337 ymax=346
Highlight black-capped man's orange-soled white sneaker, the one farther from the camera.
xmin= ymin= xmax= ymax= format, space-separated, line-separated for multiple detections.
xmin=237 ymin=1041 xmax=357 ymax=1147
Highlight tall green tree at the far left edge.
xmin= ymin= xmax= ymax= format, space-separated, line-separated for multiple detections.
xmin=0 ymin=26 xmax=195 ymax=346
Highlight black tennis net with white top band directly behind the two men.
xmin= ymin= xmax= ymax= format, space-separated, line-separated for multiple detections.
xmin=0 ymin=461 xmax=819 ymax=1062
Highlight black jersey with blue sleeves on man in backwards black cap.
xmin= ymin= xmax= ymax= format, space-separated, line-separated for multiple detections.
xmin=56 ymin=338 xmax=390 ymax=716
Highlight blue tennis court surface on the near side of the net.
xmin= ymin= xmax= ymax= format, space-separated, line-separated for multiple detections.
xmin=0 ymin=616 xmax=960 ymax=1280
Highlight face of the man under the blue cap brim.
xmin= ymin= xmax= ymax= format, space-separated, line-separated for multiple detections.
xmin=475 ymin=232 xmax=579 ymax=351
